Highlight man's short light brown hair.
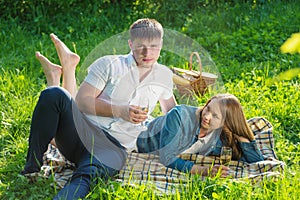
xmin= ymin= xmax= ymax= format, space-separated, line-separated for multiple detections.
xmin=130 ymin=18 xmax=164 ymax=41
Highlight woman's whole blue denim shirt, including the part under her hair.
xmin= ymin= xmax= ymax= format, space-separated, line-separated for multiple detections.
xmin=137 ymin=105 xmax=263 ymax=172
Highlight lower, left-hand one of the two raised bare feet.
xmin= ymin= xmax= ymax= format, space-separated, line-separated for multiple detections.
xmin=35 ymin=52 xmax=62 ymax=86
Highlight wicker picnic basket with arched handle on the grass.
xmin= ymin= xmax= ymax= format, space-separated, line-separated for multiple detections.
xmin=172 ymin=52 xmax=218 ymax=95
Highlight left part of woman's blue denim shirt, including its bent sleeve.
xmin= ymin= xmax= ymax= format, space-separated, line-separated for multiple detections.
xmin=137 ymin=105 xmax=199 ymax=171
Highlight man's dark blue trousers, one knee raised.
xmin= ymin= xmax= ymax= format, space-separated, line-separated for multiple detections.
xmin=22 ymin=87 xmax=127 ymax=199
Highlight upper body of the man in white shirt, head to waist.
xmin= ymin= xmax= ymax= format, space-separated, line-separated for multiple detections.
xmin=76 ymin=19 xmax=176 ymax=151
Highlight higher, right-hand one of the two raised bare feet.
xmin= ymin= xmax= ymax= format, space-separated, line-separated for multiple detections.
xmin=50 ymin=33 xmax=80 ymax=71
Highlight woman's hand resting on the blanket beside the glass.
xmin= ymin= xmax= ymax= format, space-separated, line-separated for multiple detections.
xmin=191 ymin=164 xmax=230 ymax=178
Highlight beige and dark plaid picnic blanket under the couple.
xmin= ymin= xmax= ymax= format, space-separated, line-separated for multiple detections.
xmin=42 ymin=117 xmax=285 ymax=193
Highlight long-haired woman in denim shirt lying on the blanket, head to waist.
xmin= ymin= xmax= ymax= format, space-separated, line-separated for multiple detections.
xmin=137 ymin=94 xmax=263 ymax=176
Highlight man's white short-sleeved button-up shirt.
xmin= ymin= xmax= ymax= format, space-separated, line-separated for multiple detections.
xmin=85 ymin=53 xmax=173 ymax=151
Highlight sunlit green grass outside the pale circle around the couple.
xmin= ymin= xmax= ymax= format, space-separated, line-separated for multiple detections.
xmin=0 ymin=0 xmax=300 ymax=200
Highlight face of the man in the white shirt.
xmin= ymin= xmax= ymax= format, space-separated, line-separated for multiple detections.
xmin=128 ymin=38 xmax=162 ymax=67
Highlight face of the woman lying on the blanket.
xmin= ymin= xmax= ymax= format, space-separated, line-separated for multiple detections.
xmin=201 ymin=99 xmax=224 ymax=131
